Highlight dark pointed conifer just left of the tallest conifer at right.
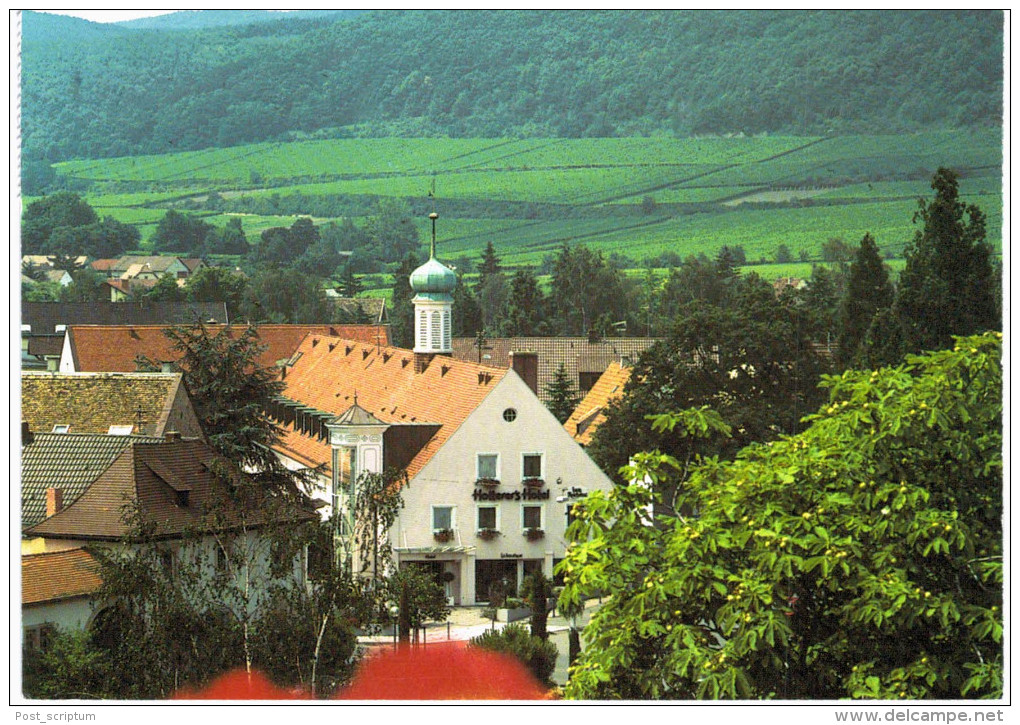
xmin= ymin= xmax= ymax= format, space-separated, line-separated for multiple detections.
xmin=836 ymin=234 xmax=894 ymax=367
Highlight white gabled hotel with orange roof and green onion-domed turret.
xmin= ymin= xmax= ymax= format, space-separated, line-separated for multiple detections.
xmin=269 ymin=217 xmax=612 ymax=605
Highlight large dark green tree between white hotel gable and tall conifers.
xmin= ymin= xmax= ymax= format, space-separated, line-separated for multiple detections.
xmin=589 ymin=276 xmax=825 ymax=499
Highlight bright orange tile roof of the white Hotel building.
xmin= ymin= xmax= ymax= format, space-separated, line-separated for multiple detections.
xmin=277 ymin=334 xmax=507 ymax=476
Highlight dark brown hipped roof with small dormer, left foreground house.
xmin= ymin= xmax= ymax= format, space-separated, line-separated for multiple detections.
xmin=26 ymin=439 xmax=318 ymax=540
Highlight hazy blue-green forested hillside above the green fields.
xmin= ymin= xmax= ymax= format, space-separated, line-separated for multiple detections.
xmin=21 ymin=11 xmax=1003 ymax=168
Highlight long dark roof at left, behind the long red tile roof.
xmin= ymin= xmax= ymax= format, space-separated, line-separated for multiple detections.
xmin=21 ymin=302 xmax=230 ymax=335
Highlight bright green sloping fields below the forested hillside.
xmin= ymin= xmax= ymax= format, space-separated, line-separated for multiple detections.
xmin=49 ymin=130 xmax=1002 ymax=276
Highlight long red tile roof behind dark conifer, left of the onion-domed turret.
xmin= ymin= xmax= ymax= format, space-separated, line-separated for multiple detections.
xmin=67 ymin=324 xmax=389 ymax=372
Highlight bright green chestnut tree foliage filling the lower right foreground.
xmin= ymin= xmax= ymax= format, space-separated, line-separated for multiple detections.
xmin=560 ymin=332 xmax=1003 ymax=700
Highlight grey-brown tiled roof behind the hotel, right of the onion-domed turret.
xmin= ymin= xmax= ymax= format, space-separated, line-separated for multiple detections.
xmin=453 ymin=338 xmax=658 ymax=403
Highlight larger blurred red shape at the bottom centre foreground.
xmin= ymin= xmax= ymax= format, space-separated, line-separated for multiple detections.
xmin=337 ymin=642 xmax=550 ymax=700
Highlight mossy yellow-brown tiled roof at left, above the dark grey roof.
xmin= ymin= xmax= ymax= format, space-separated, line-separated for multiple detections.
xmin=21 ymin=372 xmax=190 ymax=435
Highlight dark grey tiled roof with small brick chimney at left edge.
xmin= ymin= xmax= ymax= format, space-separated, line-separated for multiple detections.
xmin=21 ymin=432 xmax=162 ymax=529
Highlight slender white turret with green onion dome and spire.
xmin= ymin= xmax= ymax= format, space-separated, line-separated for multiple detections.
xmin=410 ymin=212 xmax=457 ymax=372
